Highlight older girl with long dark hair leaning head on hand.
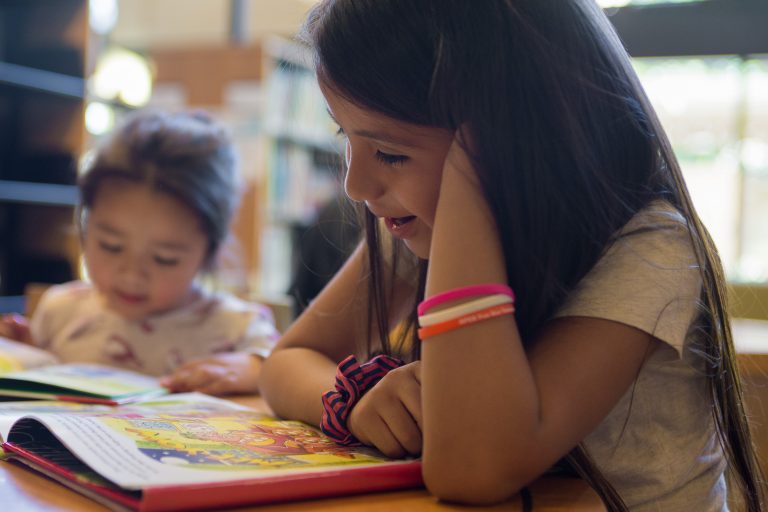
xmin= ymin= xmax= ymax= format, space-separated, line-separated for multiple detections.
xmin=261 ymin=0 xmax=763 ymax=512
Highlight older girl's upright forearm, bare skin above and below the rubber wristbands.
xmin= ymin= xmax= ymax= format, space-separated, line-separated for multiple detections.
xmin=422 ymin=151 xmax=543 ymax=501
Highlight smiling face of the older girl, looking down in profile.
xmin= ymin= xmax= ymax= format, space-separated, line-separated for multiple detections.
xmin=322 ymin=87 xmax=453 ymax=258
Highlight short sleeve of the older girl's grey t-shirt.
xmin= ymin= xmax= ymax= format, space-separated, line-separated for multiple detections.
xmin=555 ymin=202 xmax=701 ymax=356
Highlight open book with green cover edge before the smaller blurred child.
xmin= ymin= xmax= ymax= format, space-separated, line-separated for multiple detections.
xmin=0 ymin=338 xmax=168 ymax=405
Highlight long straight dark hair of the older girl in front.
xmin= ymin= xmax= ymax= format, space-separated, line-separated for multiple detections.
xmin=301 ymin=0 xmax=762 ymax=511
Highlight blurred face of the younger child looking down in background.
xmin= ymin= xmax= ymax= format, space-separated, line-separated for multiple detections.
xmin=84 ymin=180 xmax=208 ymax=320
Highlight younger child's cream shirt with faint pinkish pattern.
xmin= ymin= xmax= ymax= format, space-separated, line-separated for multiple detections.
xmin=30 ymin=281 xmax=278 ymax=376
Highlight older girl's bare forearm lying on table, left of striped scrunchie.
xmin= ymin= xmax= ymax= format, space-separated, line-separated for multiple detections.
xmin=259 ymin=348 xmax=336 ymax=425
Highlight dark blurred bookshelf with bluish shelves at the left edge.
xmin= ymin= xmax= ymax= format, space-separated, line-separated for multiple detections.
xmin=0 ymin=0 xmax=89 ymax=295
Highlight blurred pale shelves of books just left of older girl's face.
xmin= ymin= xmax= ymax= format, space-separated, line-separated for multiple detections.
xmin=258 ymin=37 xmax=343 ymax=296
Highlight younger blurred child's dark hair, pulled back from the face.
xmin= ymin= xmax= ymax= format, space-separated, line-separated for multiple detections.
xmin=77 ymin=110 xmax=238 ymax=265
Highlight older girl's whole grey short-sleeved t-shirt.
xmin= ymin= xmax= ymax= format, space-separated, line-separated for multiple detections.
xmin=555 ymin=201 xmax=727 ymax=512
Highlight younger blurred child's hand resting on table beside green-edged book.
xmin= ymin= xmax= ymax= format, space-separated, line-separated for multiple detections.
xmin=160 ymin=352 xmax=262 ymax=395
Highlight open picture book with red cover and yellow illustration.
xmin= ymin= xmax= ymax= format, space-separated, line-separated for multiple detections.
xmin=0 ymin=394 xmax=422 ymax=511
